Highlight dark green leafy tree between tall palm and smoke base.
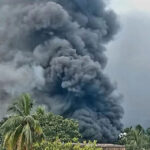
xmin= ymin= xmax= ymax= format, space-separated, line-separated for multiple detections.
xmin=35 ymin=107 xmax=81 ymax=142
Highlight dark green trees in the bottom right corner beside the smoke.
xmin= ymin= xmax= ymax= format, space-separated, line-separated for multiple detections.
xmin=119 ymin=125 xmax=150 ymax=150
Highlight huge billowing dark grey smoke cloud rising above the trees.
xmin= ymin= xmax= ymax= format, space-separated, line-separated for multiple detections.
xmin=0 ymin=0 xmax=123 ymax=142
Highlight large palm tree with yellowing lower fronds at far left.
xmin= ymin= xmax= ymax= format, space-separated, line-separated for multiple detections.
xmin=0 ymin=94 xmax=43 ymax=150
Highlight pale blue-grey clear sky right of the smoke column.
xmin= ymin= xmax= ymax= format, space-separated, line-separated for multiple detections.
xmin=106 ymin=0 xmax=150 ymax=127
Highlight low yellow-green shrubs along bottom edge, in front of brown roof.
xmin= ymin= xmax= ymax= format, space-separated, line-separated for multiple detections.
xmin=33 ymin=140 xmax=102 ymax=150
